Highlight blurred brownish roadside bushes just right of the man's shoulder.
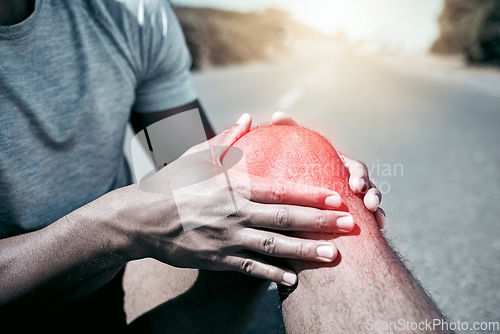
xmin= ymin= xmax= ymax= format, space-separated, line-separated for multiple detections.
xmin=174 ymin=7 xmax=331 ymax=69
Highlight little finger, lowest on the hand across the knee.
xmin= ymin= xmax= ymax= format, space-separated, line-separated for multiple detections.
xmin=227 ymin=256 xmax=297 ymax=286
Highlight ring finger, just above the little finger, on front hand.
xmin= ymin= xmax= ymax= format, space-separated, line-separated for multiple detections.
xmin=240 ymin=228 xmax=338 ymax=262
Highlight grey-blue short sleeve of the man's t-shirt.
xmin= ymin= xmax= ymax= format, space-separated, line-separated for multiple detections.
xmin=133 ymin=0 xmax=197 ymax=113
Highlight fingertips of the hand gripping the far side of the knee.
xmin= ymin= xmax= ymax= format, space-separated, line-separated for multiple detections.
xmin=272 ymin=111 xmax=385 ymax=229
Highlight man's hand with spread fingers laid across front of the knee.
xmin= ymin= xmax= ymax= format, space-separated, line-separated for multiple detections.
xmin=124 ymin=114 xmax=354 ymax=285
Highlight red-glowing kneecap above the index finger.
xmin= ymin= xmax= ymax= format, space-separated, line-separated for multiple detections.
xmin=230 ymin=125 xmax=348 ymax=195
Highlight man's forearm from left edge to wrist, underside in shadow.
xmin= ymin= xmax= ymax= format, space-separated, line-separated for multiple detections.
xmin=0 ymin=187 xmax=136 ymax=305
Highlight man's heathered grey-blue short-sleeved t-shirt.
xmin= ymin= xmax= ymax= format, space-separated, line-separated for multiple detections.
xmin=0 ymin=0 xmax=196 ymax=238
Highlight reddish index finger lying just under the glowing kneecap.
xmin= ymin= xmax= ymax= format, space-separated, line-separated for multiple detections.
xmin=248 ymin=175 xmax=342 ymax=209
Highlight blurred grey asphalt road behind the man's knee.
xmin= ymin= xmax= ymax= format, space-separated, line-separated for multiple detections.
xmin=189 ymin=44 xmax=500 ymax=333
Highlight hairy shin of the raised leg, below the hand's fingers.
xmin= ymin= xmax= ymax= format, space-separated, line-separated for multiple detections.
xmin=281 ymin=191 xmax=448 ymax=334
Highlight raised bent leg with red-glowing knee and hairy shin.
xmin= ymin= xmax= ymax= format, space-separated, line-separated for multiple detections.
xmin=234 ymin=125 xmax=452 ymax=334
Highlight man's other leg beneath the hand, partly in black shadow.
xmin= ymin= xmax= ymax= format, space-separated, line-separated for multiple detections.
xmin=123 ymin=259 xmax=268 ymax=334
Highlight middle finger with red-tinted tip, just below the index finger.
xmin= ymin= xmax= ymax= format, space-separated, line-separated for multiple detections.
xmin=247 ymin=204 xmax=354 ymax=233
